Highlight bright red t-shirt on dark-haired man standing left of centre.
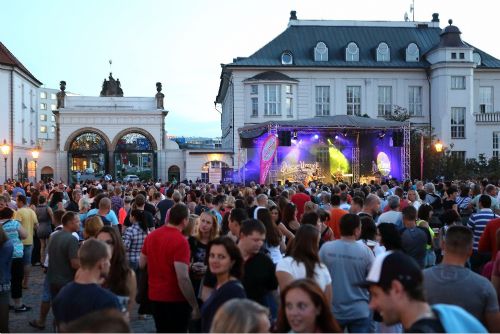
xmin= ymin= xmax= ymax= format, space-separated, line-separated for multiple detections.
xmin=142 ymin=225 xmax=191 ymax=302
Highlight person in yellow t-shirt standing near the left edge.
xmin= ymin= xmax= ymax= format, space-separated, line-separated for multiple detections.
xmin=14 ymin=194 xmax=38 ymax=289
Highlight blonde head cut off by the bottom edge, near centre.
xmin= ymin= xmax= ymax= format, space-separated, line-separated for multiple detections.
xmin=210 ymin=298 xmax=271 ymax=333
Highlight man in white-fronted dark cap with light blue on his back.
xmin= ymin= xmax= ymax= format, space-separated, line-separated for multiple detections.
xmin=361 ymin=251 xmax=487 ymax=333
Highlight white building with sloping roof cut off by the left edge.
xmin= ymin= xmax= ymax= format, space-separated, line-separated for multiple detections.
xmin=0 ymin=42 xmax=42 ymax=182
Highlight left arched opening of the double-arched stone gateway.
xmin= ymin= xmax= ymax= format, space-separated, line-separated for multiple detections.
xmin=68 ymin=132 xmax=108 ymax=182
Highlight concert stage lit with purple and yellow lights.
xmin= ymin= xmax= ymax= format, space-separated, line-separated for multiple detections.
xmin=237 ymin=115 xmax=410 ymax=183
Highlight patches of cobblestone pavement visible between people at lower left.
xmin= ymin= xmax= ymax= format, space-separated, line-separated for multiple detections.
xmin=9 ymin=267 xmax=156 ymax=333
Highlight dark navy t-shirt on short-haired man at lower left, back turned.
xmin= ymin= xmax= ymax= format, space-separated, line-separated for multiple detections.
xmin=52 ymin=282 xmax=122 ymax=323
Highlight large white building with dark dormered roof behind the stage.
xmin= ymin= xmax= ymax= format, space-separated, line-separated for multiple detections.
xmin=216 ymin=11 xmax=500 ymax=177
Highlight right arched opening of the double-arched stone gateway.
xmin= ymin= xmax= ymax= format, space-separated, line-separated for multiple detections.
xmin=114 ymin=132 xmax=156 ymax=180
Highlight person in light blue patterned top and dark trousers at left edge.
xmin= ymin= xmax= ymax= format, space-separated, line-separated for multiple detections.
xmin=0 ymin=206 xmax=31 ymax=313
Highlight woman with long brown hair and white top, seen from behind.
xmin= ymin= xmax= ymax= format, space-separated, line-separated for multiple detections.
xmin=276 ymin=224 xmax=332 ymax=302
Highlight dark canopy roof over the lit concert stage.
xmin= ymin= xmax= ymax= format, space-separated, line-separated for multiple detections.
xmin=238 ymin=115 xmax=405 ymax=139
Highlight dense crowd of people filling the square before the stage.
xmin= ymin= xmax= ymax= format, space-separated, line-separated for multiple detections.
xmin=0 ymin=179 xmax=500 ymax=333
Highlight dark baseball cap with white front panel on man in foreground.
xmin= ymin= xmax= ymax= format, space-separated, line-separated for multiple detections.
xmin=358 ymin=251 xmax=423 ymax=287
